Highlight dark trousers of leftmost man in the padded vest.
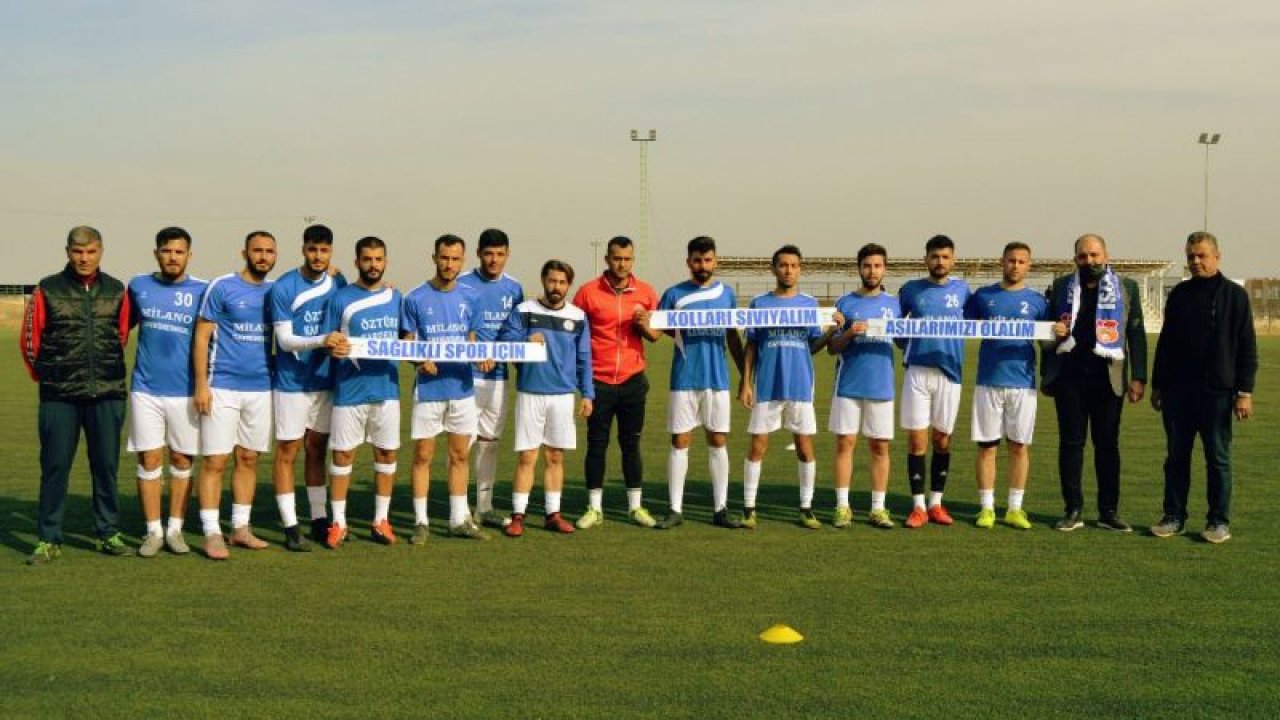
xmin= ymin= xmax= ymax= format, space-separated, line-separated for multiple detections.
xmin=37 ymin=400 xmax=124 ymax=543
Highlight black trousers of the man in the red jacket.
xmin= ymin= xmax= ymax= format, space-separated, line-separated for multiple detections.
xmin=585 ymin=373 xmax=649 ymax=489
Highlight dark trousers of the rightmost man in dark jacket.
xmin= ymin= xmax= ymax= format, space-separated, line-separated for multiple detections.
xmin=1161 ymin=388 xmax=1235 ymax=525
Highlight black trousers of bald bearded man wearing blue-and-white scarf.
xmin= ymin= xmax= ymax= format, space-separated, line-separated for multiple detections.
xmin=1053 ymin=373 xmax=1124 ymax=516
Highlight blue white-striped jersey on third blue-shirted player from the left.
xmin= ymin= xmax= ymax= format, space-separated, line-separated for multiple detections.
xmin=268 ymin=268 xmax=347 ymax=392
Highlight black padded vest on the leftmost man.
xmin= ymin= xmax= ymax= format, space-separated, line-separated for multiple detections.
xmin=36 ymin=265 xmax=125 ymax=400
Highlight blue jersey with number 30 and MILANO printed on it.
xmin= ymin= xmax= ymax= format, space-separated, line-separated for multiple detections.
xmin=129 ymin=274 xmax=209 ymax=397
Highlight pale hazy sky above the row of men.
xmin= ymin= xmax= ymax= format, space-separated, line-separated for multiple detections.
xmin=0 ymin=0 xmax=1280 ymax=287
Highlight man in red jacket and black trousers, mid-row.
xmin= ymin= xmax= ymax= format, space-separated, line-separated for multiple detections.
xmin=573 ymin=236 xmax=659 ymax=530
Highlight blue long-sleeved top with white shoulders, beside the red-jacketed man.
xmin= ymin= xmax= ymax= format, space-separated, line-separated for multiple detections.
xmin=498 ymin=300 xmax=595 ymax=398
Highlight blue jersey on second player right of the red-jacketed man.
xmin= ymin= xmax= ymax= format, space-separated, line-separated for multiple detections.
xmin=746 ymin=292 xmax=822 ymax=402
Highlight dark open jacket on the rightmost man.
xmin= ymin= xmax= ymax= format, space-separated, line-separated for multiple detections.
xmin=1151 ymin=275 xmax=1258 ymax=392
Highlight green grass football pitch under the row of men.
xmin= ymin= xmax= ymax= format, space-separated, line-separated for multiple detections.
xmin=0 ymin=332 xmax=1280 ymax=717
